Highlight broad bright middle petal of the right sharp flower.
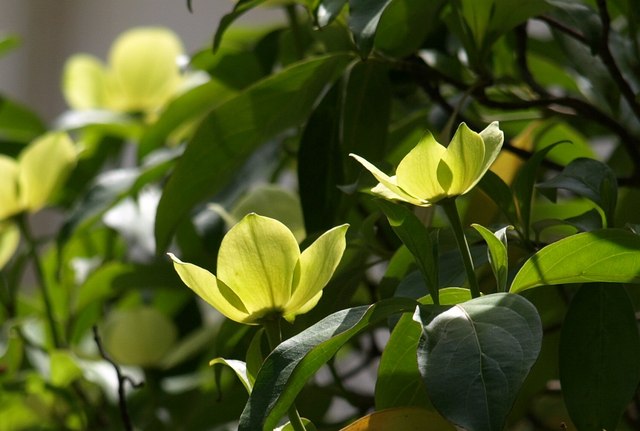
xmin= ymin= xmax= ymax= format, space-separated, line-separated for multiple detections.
xmin=396 ymin=132 xmax=446 ymax=203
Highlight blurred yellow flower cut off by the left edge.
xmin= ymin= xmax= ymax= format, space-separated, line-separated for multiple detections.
xmin=0 ymin=132 xmax=77 ymax=220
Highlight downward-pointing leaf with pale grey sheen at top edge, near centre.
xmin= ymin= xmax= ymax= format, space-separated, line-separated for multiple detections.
xmin=349 ymin=0 xmax=391 ymax=58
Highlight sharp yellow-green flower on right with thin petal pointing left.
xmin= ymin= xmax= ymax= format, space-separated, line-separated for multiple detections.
xmin=350 ymin=122 xmax=504 ymax=207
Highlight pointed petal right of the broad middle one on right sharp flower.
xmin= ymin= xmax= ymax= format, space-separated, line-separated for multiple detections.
xmin=438 ymin=123 xmax=485 ymax=196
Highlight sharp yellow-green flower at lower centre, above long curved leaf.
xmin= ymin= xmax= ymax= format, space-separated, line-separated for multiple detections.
xmin=169 ymin=213 xmax=348 ymax=324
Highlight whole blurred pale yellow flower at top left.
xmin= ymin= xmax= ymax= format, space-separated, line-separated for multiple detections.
xmin=63 ymin=27 xmax=183 ymax=113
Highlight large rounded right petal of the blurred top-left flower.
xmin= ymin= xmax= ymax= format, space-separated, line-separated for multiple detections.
xmin=109 ymin=27 xmax=183 ymax=111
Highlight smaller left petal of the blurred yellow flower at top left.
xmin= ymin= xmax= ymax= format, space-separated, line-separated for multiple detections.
xmin=62 ymin=54 xmax=106 ymax=109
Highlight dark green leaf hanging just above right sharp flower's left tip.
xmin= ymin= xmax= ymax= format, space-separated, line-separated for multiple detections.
xmin=340 ymin=61 xmax=391 ymax=182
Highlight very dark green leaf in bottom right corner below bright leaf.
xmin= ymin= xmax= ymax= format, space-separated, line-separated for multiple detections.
xmin=559 ymin=283 xmax=640 ymax=430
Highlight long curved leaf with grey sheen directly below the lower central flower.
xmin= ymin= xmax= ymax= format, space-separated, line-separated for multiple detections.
xmin=238 ymin=298 xmax=416 ymax=431
